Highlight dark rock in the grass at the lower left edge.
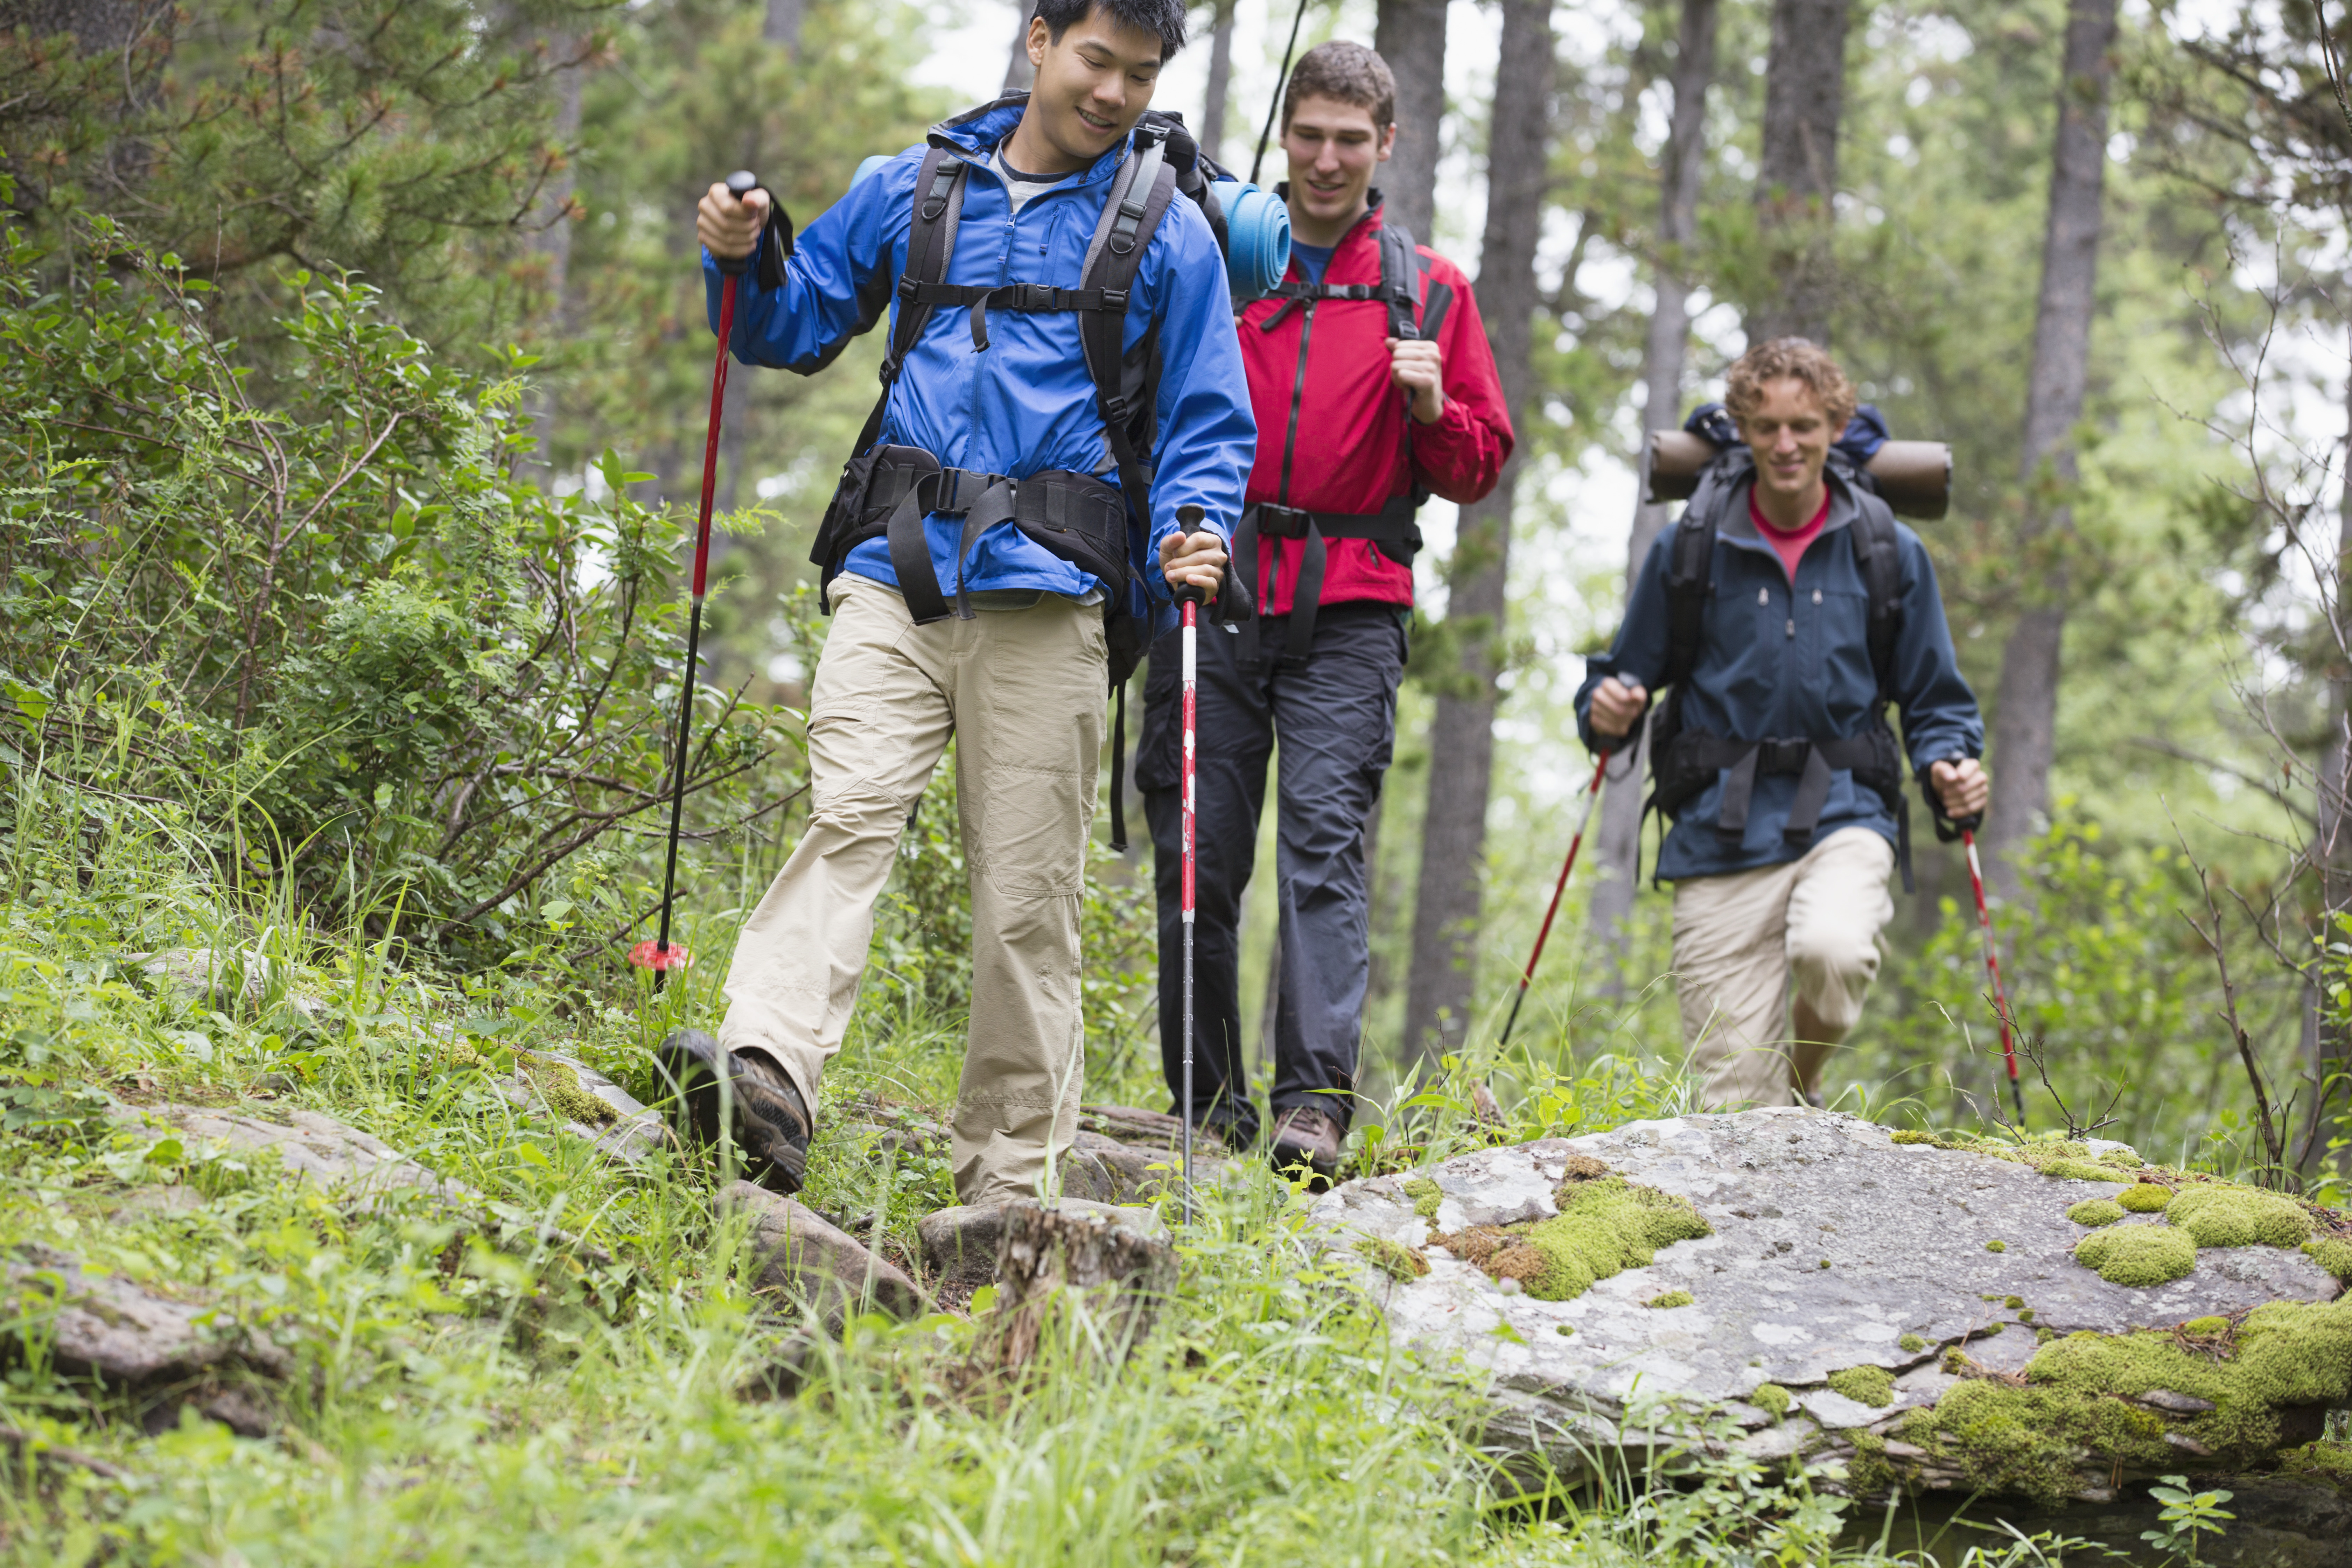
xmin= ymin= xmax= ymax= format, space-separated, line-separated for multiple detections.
xmin=5 ymin=1246 xmax=292 ymax=1387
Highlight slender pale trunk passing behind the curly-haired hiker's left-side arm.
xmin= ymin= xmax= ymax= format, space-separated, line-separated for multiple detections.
xmin=1590 ymin=0 xmax=1719 ymax=964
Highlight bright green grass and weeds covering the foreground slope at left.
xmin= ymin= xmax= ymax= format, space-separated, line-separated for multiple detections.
xmin=0 ymin=776 xmax=2135 ymax=1563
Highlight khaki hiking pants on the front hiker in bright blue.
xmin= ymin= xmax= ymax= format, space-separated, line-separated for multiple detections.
xmin=720 ymin=574 xmax=1108 ymax=1204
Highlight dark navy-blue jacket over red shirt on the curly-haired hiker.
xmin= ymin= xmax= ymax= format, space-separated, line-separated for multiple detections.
xmin=1576 ymin=470 xmax=1985 ymax=882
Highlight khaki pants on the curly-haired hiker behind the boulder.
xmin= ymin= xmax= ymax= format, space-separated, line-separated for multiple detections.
xmin=1675 ymin=827 xmax=1896 ymax=1110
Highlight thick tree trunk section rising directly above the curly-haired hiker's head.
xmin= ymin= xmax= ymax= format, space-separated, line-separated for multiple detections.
xmin=1748 ymin=0 xmax=1846 ymax=343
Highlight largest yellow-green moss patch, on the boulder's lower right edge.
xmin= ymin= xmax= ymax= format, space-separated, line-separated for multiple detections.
xmin=1900 ymin=1297 xmax=2352 ymax=1505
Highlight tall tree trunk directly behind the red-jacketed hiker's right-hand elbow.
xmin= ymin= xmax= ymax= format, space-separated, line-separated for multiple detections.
xmin=1402 ymin=0 xmax=1552 ymax=1063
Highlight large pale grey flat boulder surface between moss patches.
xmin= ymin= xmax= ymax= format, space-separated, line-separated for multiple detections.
xmin=1308 ymin=1107 xmax=2338 ymax=1495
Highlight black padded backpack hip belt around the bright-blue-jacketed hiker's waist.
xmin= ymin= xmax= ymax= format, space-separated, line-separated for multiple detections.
xmin=837 ymin=447 xmax=1129 ymax=625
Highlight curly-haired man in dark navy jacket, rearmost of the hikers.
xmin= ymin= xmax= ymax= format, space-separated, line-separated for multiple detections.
xmin=1576 ymin=338 xmax=1992 ymax=1107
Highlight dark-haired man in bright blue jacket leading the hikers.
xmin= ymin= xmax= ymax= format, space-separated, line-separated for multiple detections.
xmin=661 ymin=0 xmax=1256 ymax=1206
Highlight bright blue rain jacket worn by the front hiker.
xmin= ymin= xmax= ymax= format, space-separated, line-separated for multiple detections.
xmin=703 ymin=101 xmax=1258 ymax=635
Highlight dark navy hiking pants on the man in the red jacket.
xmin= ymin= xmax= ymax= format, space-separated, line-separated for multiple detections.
xmin=1136 ymin=604 xmax=1404 ymax=1147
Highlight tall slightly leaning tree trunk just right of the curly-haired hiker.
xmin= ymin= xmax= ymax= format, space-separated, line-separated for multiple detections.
xmin=1985 ymin=0 xmax=2114 ymax=896
